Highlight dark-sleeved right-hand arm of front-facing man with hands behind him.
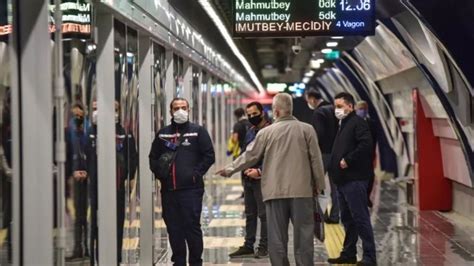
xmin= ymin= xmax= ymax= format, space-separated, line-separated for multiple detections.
xmin=194 ymin=127 xmax=216 ymax=177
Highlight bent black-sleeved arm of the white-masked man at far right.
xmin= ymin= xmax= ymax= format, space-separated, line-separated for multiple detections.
xmin=344 ymin=121 xmax=373 ymax=167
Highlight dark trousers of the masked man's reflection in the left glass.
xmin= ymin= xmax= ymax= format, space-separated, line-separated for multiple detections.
xmin=74 ymin=179 xmax=88 ymax=252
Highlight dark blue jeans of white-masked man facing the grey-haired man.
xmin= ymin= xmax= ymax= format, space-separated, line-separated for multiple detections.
xmin=337 ymin=180 xmax=376 ymax=262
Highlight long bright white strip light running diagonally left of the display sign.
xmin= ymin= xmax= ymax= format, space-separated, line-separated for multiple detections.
xmin=199 ymin=0 xmax=264 ymax=93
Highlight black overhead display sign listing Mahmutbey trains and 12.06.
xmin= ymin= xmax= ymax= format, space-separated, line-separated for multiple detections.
xmin=232 ymin=0 xmax=375 ymax=37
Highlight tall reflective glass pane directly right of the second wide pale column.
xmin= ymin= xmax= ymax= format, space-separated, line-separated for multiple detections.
xmin=111 ymin=21 xmax=139 ymax=263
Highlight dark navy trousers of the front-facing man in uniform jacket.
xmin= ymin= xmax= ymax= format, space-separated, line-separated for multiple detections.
xmin=161 ymin=188 xmax=204 ymax=266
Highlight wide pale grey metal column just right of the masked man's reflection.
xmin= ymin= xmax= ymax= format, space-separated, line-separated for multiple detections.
xmin=95 ymin=13 xmax=117 ymax=265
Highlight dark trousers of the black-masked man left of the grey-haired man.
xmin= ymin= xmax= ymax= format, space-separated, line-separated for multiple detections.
xmin=244 ymin=179 xmax=268 ymax=249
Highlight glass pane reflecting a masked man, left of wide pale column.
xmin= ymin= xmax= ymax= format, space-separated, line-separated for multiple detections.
xmin=61 ymin=39 xmax=97 ymax=261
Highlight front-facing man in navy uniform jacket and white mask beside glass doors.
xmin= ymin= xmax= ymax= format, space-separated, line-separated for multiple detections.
xmin=149 ymin=98 xmax=215 ymax=265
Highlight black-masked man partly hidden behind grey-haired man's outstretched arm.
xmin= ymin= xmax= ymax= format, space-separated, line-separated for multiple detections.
xmin=229 ymin=102 xmax=271 ymax=258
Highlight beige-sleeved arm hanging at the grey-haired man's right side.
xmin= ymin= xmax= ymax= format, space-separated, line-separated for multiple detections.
xmin=307 ymin=130 xmax=326 ymax=191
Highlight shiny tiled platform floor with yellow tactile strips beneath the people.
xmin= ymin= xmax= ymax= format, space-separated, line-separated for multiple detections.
xmin=146 ymin=178 xmax=474 ymax=266
